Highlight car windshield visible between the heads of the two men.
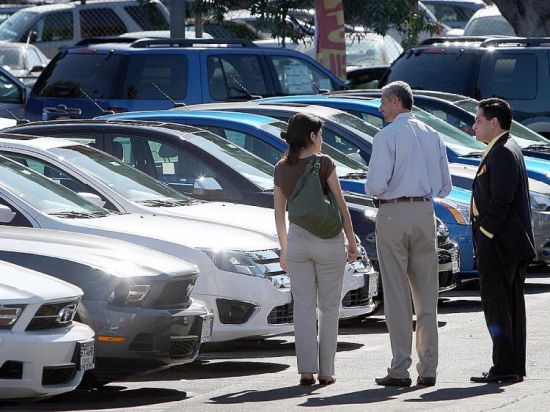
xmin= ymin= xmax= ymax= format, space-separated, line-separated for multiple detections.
xmin=413 ymin=107 xmax=486 ymax=156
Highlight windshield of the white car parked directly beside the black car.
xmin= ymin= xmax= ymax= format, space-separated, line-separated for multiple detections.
xmin=51 ymin=145 xmax=192 ymax=205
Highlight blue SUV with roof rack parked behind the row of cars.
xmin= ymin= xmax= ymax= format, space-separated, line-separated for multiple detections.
xmin=26 ymin=38 xmax=345 ymax=120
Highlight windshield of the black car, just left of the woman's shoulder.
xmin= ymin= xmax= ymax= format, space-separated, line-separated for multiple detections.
xmin=190 ymin=131 xmax=274 ymax=190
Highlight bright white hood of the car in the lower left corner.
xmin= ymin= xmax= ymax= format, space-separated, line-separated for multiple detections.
xmin=0 ymin=261 xmax=82 ymax=304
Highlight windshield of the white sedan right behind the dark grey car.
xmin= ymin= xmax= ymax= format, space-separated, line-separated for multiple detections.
xmin=0 ymin=157 xmax=109 ymax=218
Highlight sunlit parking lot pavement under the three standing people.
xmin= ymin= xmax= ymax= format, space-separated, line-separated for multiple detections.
xmin=4 ymin=272 xmax=550 ymax=412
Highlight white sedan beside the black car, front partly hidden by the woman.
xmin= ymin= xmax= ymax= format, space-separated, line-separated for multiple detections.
xmin=0 ymin=138 xmax=378 ymax=322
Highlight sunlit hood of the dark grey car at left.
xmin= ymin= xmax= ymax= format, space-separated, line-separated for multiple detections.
xmin=0 ymin=228 xmax=198 ymax=277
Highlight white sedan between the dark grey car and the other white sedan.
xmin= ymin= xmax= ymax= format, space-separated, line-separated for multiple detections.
xmin=0 ymin=154 xmax=292 ymax=341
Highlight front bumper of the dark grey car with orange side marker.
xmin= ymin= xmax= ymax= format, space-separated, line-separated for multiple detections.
xmin=82 ymin=301 xmax=213 ymax=379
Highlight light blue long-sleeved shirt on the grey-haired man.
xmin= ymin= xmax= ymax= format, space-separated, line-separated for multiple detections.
xmin=366 ymin=112 xmax=452 ymax=200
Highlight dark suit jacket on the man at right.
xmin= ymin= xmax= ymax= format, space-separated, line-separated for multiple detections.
xmin=472 ymin=133 xmax=536 ymax=276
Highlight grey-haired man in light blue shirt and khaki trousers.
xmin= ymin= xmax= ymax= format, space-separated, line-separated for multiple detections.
xmin=366 ymin=81 xmax=452 ymax=386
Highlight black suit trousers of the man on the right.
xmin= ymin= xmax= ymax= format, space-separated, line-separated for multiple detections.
xmin=474 ymin=233 xmax=527 ymax=376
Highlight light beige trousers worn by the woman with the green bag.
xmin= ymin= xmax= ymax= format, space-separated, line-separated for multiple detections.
xmin=287 ymin=224 xmax=346 ymax=376
